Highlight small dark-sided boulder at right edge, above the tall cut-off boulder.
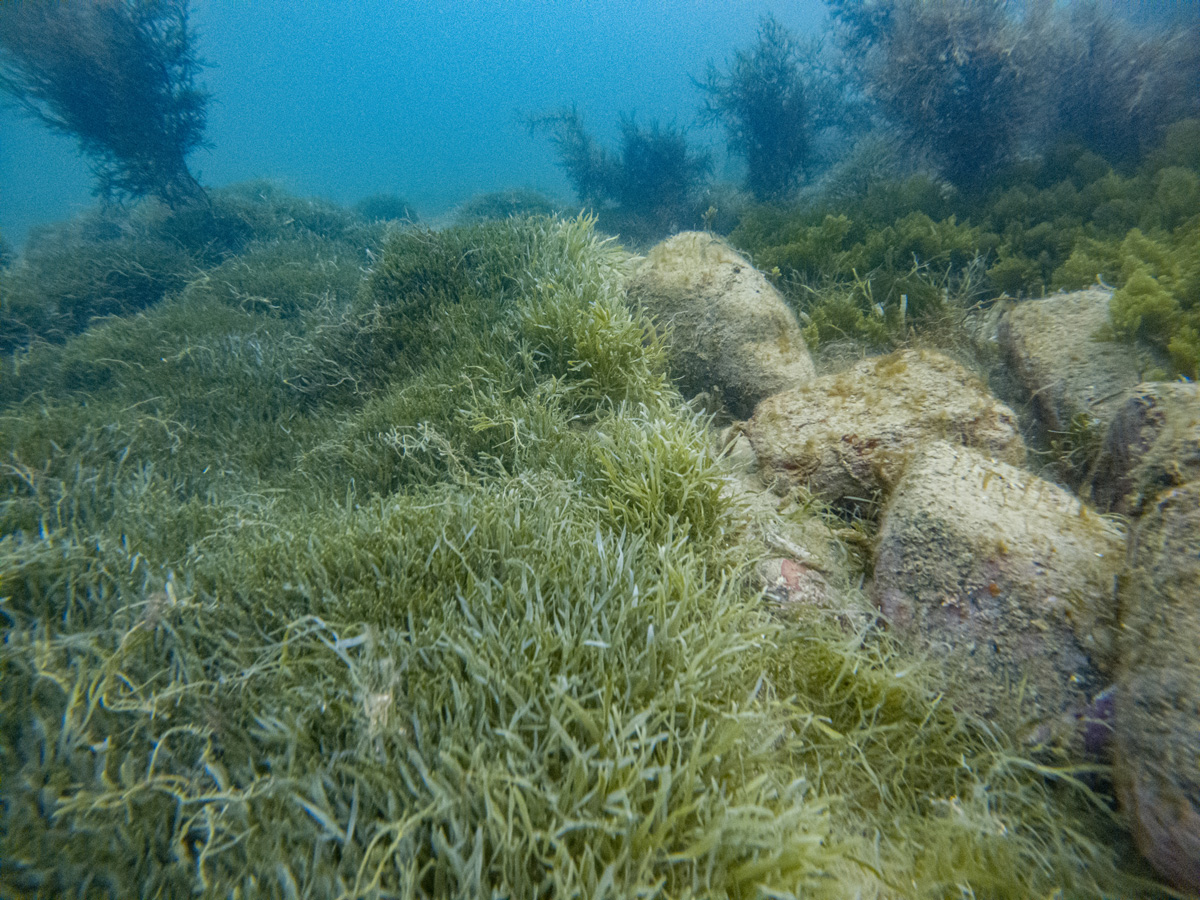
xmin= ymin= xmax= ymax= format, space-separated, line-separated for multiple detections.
xmin=1092 ymin=382 xmax=1200 ymax=515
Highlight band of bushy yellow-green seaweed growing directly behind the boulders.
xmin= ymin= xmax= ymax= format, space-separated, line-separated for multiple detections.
xmin=730 ymin=120 xmax=1200 ymax=378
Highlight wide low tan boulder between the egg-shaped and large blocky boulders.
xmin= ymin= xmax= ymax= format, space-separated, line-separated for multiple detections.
xmin=746 ymin=350 xmax=1025 ymax=504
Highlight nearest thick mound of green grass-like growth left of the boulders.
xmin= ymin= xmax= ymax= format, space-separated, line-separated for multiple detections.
xmin=0 ymin=211 xmax=1156 ymax=898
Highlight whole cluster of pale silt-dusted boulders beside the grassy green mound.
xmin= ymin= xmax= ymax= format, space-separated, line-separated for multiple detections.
xmin=676 ymin=254 xmax=1200 ymax=893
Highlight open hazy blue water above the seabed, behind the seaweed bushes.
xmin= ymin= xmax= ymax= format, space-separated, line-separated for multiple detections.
xmin=0 ymin=0 xmax=824 ymax=245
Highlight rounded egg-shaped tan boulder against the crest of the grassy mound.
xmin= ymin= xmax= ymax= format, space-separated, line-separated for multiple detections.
xmin=628 ymin=232 xmax=814 ymax=419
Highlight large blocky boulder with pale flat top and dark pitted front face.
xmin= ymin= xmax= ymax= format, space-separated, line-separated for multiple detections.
xmin=871 ymin=443 xmax=1124 ymax=743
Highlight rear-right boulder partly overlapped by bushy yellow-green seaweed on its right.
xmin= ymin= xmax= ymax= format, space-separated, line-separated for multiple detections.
xmin=1000 ymin=290 xmax=1141 ymax=431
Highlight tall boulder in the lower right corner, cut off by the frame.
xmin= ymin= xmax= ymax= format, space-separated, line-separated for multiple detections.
xmin=1115 ymin=481 xmax=1200 ymax=892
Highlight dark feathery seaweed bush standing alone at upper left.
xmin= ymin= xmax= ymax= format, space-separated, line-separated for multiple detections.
xmin=0 ymin=0 xmax=209 ymax=205
